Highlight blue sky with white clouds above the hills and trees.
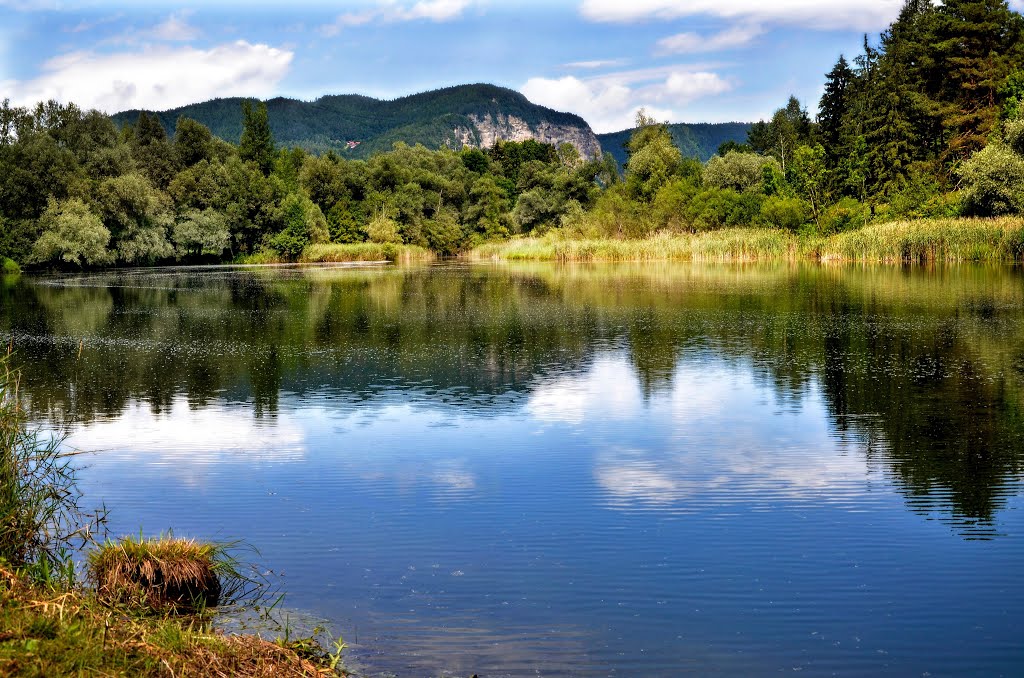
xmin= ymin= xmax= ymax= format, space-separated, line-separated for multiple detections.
xmin=0 ymin=0 xmax=1024 ymax=133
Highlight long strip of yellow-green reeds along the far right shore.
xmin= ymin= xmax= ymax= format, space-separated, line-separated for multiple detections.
xmin=469 ymin=217 xmax=1024 ymax=263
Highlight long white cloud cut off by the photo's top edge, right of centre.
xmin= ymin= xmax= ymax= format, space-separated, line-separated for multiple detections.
xmin=580 ymin=0 xmax=903 ymax=31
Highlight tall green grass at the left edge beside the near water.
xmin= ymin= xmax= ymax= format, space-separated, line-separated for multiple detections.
xmin=0 ymin=353 xmax=105 ymax=583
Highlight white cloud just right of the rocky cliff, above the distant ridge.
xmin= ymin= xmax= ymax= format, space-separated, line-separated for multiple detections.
xmin=519 ymin=67 xmax=732 ymax=133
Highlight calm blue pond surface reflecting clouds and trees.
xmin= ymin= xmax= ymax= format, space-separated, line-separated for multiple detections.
xmin=0 ymin=264 xmax=1024 ymax=678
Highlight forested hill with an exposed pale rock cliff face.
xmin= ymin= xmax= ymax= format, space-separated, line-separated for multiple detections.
xmin=114 ymin=84 xmax=600 ymax=158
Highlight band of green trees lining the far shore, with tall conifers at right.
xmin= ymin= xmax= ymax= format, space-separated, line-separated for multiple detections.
xmin=0 ymin=0 xmax=1024 ymax=268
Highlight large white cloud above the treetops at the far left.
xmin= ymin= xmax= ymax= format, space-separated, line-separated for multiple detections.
xmin=0 ymin=41 xmax=293 ymax=113
